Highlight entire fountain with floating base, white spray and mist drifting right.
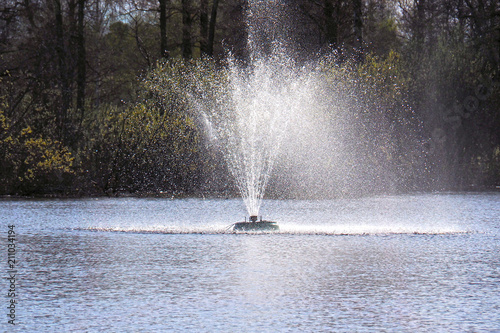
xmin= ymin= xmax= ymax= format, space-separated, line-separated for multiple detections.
xmin=167 ymin=0 xmax=420 ymax=231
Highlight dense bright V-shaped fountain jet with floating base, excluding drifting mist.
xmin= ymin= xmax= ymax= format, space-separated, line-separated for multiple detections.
xmin=189 ymin=1 xmax=314 ymax=231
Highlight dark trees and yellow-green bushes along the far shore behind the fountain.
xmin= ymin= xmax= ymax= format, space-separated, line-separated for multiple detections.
xmin=0 ymin=0 xmax=500 ymax=195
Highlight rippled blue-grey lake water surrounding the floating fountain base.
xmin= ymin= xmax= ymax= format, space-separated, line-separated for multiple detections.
xmin=0 ymin=193 xmax=500 ymax=332
